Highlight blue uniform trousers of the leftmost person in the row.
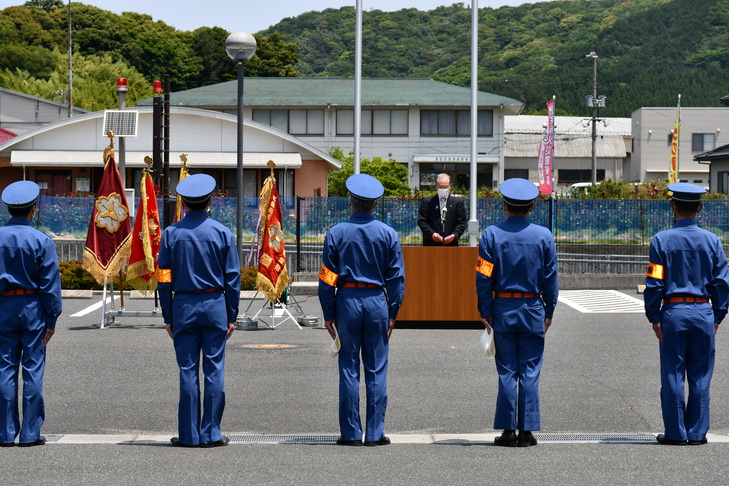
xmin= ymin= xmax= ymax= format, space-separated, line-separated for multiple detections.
xmin=0 ymin=295 xmax=46 ymax=442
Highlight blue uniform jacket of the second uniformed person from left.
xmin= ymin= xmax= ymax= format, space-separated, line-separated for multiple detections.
xmin=158 ymin=211 xmax=240 ymax=324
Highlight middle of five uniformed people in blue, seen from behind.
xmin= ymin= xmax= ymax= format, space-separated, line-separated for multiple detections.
xmin=319 ymin=174 xmax=405 ymax=446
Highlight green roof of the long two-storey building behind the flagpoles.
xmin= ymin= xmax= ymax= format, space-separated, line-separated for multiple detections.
xmin=138 ymin=78 xmax=524 ymax=114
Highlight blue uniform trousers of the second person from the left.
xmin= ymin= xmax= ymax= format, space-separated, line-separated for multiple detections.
xmin=172 ymin=291 xmax=228 ymax=445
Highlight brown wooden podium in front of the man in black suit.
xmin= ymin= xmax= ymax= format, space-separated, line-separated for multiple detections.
xmin=397 ymin=246 xmax=481 ymax=322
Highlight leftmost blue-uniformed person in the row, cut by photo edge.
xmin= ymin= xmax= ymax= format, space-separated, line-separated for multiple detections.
xmin=0 ymin=181 xmax=62 ymax=447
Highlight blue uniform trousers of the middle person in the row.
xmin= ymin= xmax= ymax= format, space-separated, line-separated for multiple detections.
xmin=335 ymin=288 xmax=389 ymax=441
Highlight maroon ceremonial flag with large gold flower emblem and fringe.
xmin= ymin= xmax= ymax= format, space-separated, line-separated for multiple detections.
xmin=84 ymin=139 xmax=131 ymax=284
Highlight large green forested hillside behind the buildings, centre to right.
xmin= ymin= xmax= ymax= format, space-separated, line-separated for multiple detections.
xmin=261 ymin=0 xmax=729 ymax=116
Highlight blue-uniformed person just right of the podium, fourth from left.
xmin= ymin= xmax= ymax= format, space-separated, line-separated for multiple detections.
xmin=476 ymin=178 xmax=559 ymax=447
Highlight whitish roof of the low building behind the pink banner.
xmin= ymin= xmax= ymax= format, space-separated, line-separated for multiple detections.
xmin=504 ymin=115 xmax=631 ymax=158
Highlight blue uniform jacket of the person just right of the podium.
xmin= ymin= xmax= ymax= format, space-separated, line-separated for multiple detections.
xmin=476 ymin=216 xmax=559 ymax=319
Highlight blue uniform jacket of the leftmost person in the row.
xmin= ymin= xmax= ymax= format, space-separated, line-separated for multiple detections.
xmin=0 ymin=218 xmax=63 ymax=329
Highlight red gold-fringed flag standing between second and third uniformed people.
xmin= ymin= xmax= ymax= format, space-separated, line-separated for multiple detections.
xmin=256 ymin=162 xmax=290 ymax=302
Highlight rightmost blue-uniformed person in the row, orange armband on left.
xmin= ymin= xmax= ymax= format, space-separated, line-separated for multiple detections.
xmin=643 ymin=182 xmax=729 ymax=445
